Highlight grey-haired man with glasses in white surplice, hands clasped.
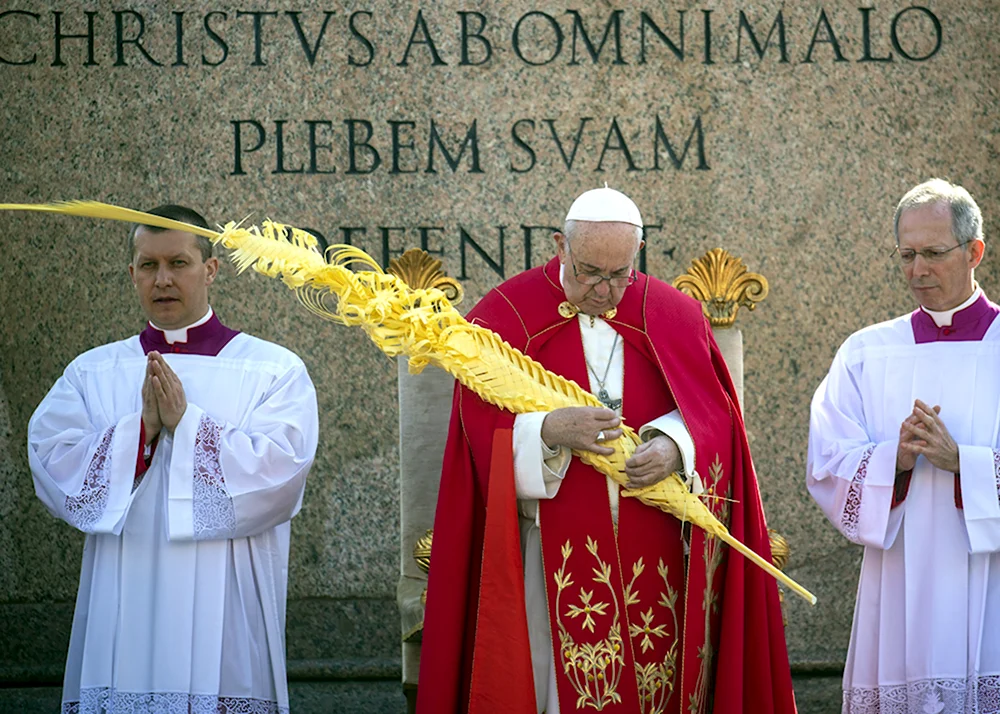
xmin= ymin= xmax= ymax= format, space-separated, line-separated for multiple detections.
xmin=807 ymin=180 xmax=1000 ymax=714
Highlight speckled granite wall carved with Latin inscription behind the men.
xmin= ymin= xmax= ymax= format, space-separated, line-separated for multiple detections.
xmin=0 ymin=0 xmax=1000 ymax=711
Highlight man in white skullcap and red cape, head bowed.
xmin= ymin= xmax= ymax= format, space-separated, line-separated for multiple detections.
xmin=417 ymin=187 xmax=794 ymax=714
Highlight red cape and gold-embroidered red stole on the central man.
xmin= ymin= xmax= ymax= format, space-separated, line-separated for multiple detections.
xmin=417 ymin=259 xmax=795 ymax=714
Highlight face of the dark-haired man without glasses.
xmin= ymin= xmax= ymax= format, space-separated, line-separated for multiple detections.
xmin=128 ymin=227 xmax=219 ymax=330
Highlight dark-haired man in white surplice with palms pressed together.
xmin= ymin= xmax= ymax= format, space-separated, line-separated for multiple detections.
xmin=28 ymin=206 xmax=317 ymax=714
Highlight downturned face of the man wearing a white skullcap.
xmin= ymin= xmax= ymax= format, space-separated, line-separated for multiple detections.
xmin=555 ymin=221 xmax=642 ymax=315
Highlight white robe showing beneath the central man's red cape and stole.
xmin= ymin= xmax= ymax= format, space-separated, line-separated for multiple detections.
xmin=513 ymin=314 xmax=700 ymax=714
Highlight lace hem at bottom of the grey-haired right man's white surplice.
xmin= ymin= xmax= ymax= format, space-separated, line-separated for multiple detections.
xmin=841 ymin=674 xmax=1000 ymax=714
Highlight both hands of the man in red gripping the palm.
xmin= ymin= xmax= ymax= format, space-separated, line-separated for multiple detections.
xmin=542 ymin=407 xmax=682 ymax=488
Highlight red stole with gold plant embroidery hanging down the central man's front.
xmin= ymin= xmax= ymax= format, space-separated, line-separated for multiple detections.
xmin=531 ymin=320 xmax=684 ymax=714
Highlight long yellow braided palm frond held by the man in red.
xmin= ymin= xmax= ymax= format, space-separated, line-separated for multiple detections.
xmin=0 ymin=202 xmax=816 ymax=604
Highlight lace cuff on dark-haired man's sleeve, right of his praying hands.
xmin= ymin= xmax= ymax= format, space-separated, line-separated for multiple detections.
xmin=192 ymin=414 xmax=236 ymax=540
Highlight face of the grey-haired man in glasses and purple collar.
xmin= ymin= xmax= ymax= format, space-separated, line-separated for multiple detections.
xmin=899 ymin=203 xmax=985 ymax=311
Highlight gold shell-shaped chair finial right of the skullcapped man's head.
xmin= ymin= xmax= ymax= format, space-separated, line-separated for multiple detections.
xmin=673 ymin=248 xmax=768 ymax=327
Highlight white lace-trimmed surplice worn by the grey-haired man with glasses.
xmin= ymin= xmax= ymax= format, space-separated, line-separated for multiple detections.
xmin=807 ymin=315 xmax=1000 ymax=714
